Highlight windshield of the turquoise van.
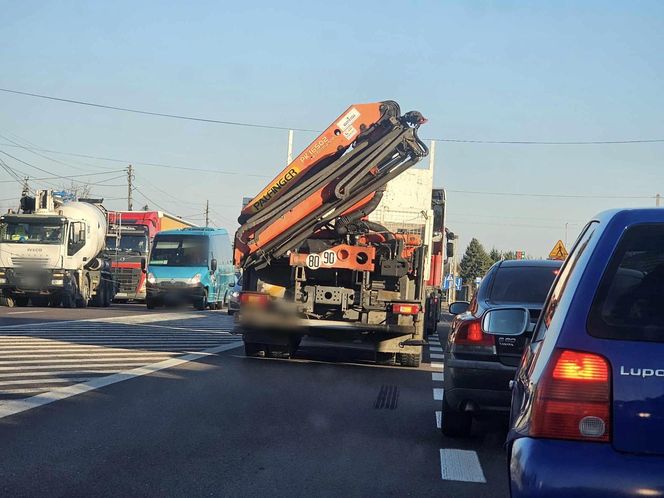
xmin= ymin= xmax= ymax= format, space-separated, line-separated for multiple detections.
xmin=150 ymin=235 xmax=208 ymax=266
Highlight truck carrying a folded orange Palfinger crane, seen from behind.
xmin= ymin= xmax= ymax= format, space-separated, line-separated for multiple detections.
xmin=234 ymin=101 xmax=429 ymax=366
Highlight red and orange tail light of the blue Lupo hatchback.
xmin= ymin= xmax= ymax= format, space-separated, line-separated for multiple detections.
xmin=530 ymin=349 xmax=611 ymax=442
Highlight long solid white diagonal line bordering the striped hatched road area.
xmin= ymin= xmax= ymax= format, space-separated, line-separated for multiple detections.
xmin=0 ymin=340 xmax=242 ymax=418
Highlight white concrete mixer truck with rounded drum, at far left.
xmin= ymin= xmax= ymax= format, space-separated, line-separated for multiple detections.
xmin=0 ymin=190 xmax=115 ymax=308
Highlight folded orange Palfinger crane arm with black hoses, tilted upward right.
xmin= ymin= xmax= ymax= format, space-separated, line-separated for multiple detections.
xmin=234 ymin=101 xmax=428 ymax=267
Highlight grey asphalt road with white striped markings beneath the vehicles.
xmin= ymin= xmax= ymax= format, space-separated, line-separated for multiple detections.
xmin=0 ymin=305 xmax=507 ymax=497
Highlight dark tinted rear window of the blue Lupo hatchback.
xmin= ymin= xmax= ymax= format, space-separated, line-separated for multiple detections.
xmin=588 ymin=223 xmax=664 ymax=342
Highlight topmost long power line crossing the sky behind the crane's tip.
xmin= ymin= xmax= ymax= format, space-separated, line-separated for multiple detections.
xmin=0 ymin=88 xmax=664 ymax=145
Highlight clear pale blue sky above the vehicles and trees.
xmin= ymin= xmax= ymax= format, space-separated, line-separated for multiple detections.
xmin=0 ymin=0 xmax=664 ymax=256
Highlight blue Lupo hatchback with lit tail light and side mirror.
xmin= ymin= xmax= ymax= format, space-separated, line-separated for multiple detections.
xmin=483 ymin=209 xmax=664 ymax=498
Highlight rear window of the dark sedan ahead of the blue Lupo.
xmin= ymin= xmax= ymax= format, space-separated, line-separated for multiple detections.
xmin=489 ymin=266 xmax=558 ymax=304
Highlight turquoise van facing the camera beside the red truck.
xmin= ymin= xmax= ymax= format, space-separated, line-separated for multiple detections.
xmin=145 ymin=227 xmax=235 ymax=310
